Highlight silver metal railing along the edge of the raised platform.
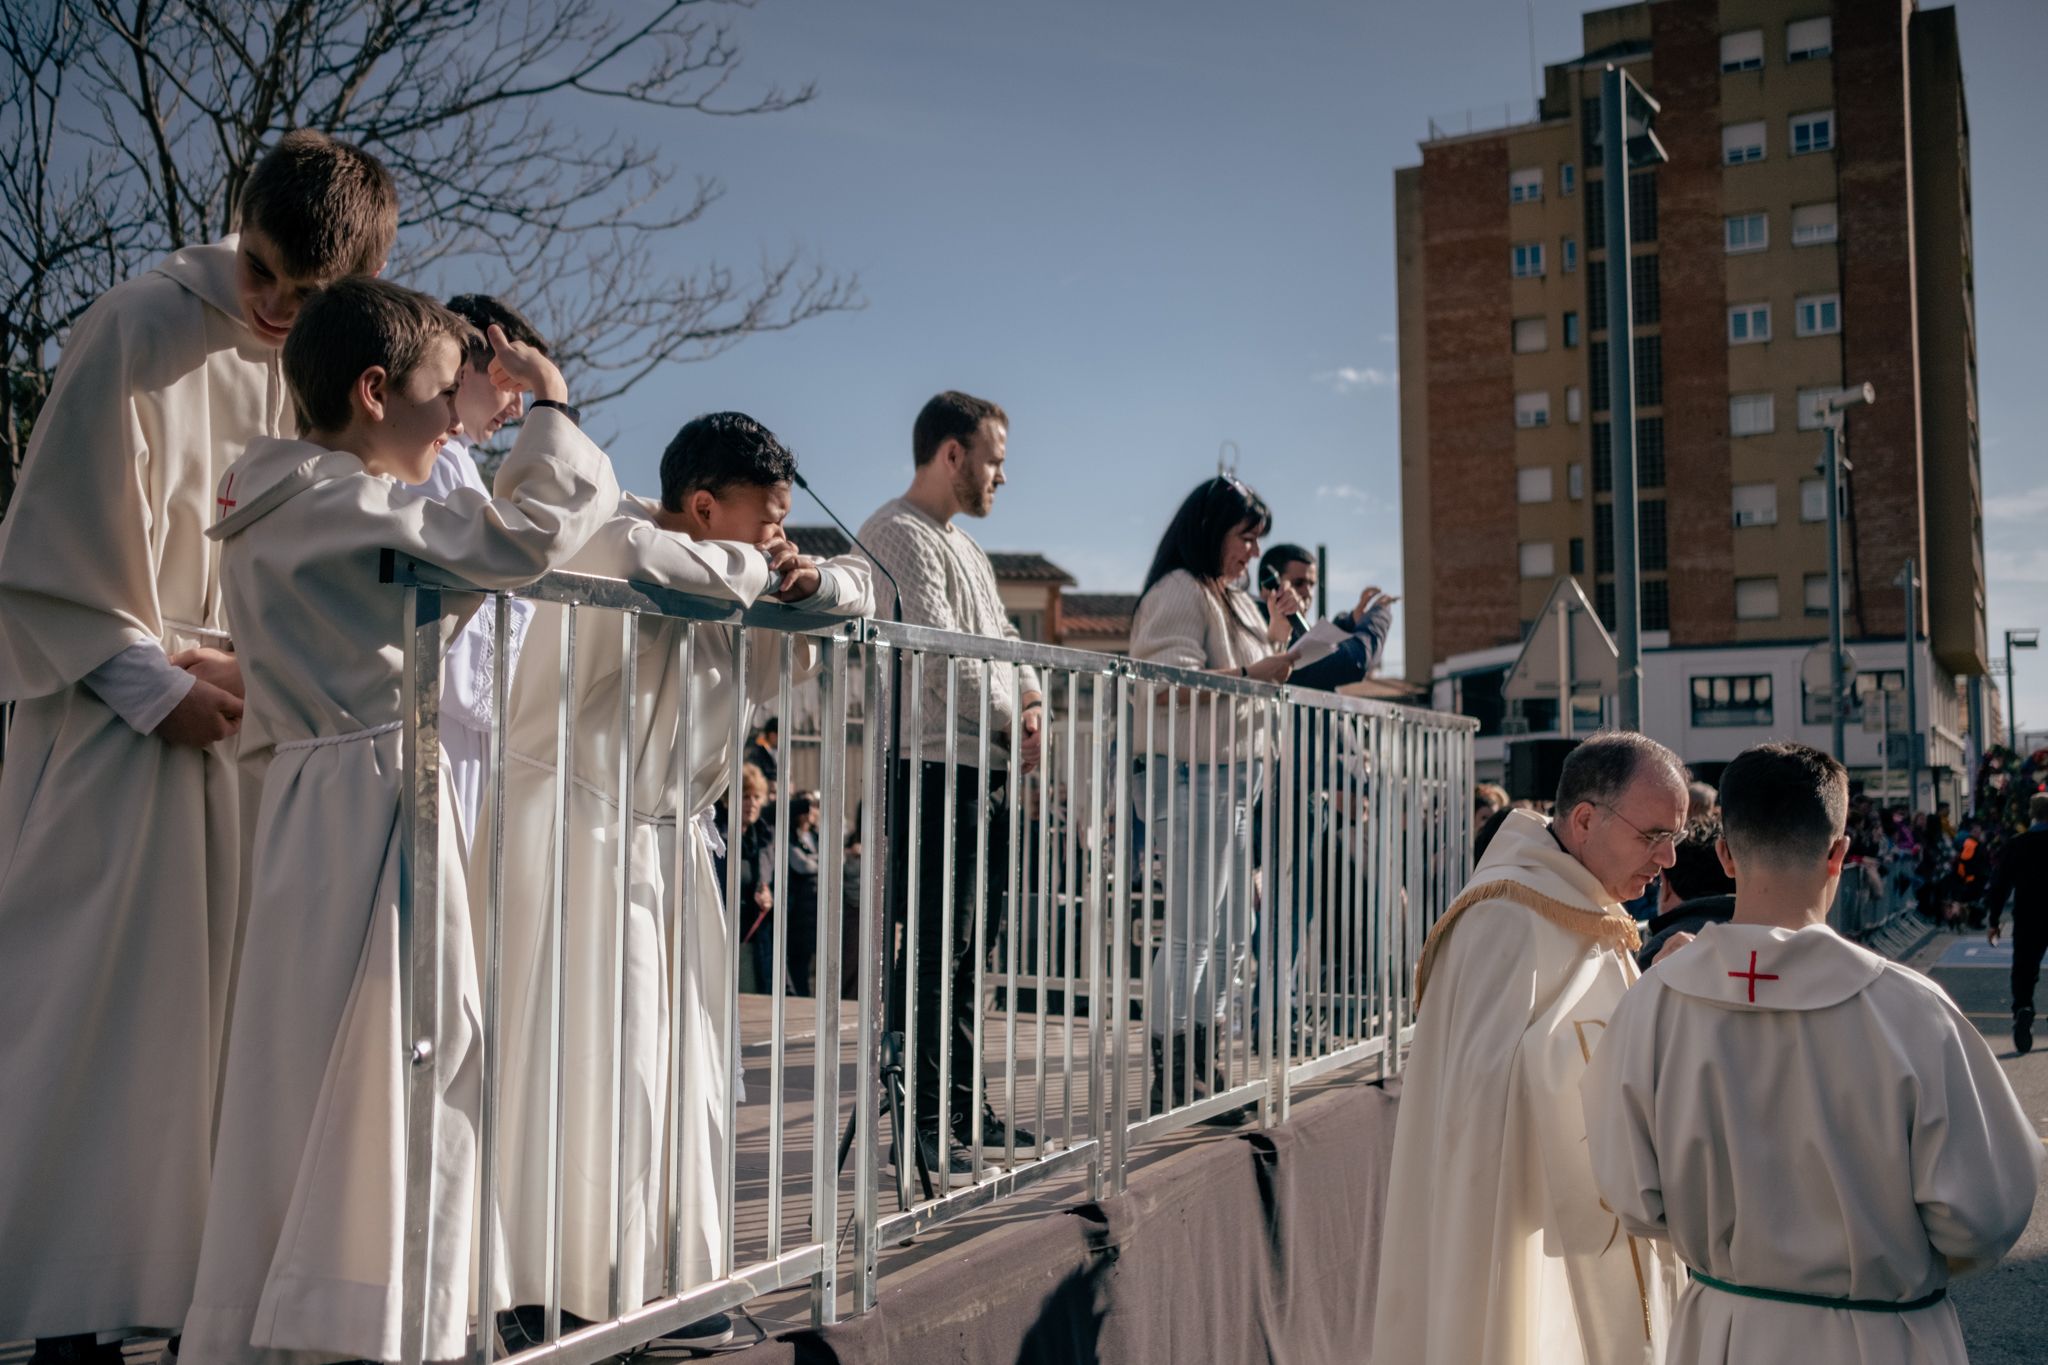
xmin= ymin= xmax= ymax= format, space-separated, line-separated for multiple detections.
xmin=385 ymin=555 xmax=1477 ymax=1365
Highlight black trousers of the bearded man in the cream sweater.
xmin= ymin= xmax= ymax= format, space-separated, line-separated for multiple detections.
xmin=889 ymin=763 xmax=1010 ymax=1130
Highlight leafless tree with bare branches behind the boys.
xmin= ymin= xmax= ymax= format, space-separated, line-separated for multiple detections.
xmin=0 ymin=0 xmax=862 ymax=514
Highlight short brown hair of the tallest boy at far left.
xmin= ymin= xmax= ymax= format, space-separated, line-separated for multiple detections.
xmin=236 ymin=129 xmax=397 ymax=280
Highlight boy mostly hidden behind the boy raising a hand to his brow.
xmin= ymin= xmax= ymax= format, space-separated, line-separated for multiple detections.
xmin=420 ymin=295 xmax=549 ymax=862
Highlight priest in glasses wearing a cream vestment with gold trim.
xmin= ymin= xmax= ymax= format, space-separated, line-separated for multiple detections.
xmin=1372 ymin=733 xmax=1686 ymax=1365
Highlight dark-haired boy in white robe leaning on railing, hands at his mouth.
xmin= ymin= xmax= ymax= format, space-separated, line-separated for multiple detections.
xmin=487 ymin=413 xmax=872 ymax=1347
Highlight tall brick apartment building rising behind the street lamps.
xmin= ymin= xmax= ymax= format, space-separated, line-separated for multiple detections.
xmin=1395 ymin=0 xmax=1987 ymax=800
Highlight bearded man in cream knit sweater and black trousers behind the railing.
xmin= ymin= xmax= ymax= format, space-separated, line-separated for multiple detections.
xmin=860 ymin=391 xmax=1044 ymax=1189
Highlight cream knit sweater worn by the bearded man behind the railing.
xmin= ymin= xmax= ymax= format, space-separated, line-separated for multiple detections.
xmin=860 ymin=497 xmax=1040 ymax=767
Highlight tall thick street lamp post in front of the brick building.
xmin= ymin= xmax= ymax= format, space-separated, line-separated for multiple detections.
xmin=1597 ymin=63 xmax=1671 ymax=731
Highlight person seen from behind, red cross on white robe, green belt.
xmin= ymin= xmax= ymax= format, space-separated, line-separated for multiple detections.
xmin=1581 ymin=743 xmax=2042 ymax=1365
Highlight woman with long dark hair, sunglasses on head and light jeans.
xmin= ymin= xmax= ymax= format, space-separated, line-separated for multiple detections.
xmin=1130 ymin=475 xmax=1303 ymax=1113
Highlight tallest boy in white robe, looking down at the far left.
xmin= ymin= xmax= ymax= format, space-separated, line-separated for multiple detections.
xmin=0 ymin=131 xmax=397 ymax=1365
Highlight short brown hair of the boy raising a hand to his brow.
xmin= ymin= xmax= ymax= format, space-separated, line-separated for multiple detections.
xmin=285 ymin=274 xmax=471 ymax=432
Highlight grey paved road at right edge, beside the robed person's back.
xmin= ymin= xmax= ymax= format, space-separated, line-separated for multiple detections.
xmin=1911 ymin=933 xmax=2048 ymax=1365
